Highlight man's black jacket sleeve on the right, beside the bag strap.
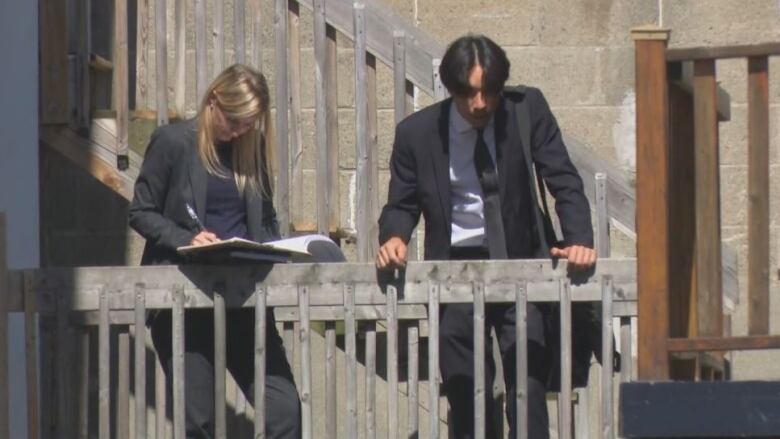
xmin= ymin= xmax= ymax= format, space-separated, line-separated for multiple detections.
xmin=527 ymin=87 xmax=593 ymax=247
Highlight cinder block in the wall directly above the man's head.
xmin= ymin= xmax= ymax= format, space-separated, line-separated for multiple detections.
xmin=418 ymin=0 xmax=541 ymax=46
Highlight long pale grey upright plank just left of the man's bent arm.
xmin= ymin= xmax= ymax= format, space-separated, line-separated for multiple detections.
xmin=353 ymin=2 xmax=373 ymax=262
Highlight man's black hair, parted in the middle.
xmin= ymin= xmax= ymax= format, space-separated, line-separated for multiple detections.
xmin=439 ymin=34 xmax=509 ymax=96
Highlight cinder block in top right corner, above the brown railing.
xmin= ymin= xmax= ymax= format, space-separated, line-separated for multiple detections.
xmin=662 ymin=0 xmax=780 ymax=47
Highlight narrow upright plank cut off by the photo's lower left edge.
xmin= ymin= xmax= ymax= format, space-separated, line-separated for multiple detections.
xmin=0 ymin=212 xmax=11 ymax=437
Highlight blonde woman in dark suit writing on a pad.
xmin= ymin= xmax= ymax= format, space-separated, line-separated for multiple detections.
xmin=129 ymin=64 xmax=300 ymax=438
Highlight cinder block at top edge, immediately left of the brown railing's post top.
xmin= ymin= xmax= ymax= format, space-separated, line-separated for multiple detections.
xmin=534 ymin=0 xmax=658 ymax=46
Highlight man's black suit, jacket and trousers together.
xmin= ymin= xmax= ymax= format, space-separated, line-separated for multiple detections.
xmin=379 ymin=88 xmax=593 ymax=438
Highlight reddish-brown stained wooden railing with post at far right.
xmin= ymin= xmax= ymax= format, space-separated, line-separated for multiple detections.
xmin=634 ymin=27 xmax=780 ymax=380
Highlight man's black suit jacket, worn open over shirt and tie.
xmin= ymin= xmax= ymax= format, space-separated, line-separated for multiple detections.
xmin=379 ymin=87 xmax=593 ymax=260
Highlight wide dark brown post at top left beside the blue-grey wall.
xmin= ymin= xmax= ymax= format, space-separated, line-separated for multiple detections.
xmin=39 ymin=2 xmax=68 ymax=124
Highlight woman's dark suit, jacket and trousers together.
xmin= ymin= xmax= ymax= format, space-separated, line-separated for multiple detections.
xmin=129 ymin=120 xmax=300 ymax=439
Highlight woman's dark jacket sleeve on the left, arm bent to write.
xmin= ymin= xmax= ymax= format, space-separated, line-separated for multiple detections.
xmin=128 ymin=128 xmax=195 ymax=250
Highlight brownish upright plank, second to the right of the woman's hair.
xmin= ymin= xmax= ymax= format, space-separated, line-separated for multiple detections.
xmin=287 ymin=0 xmax=307 ymax=230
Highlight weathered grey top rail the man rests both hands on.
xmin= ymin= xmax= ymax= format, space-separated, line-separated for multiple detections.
xmin=9 ymin=259 xmax=636 ymax=313
